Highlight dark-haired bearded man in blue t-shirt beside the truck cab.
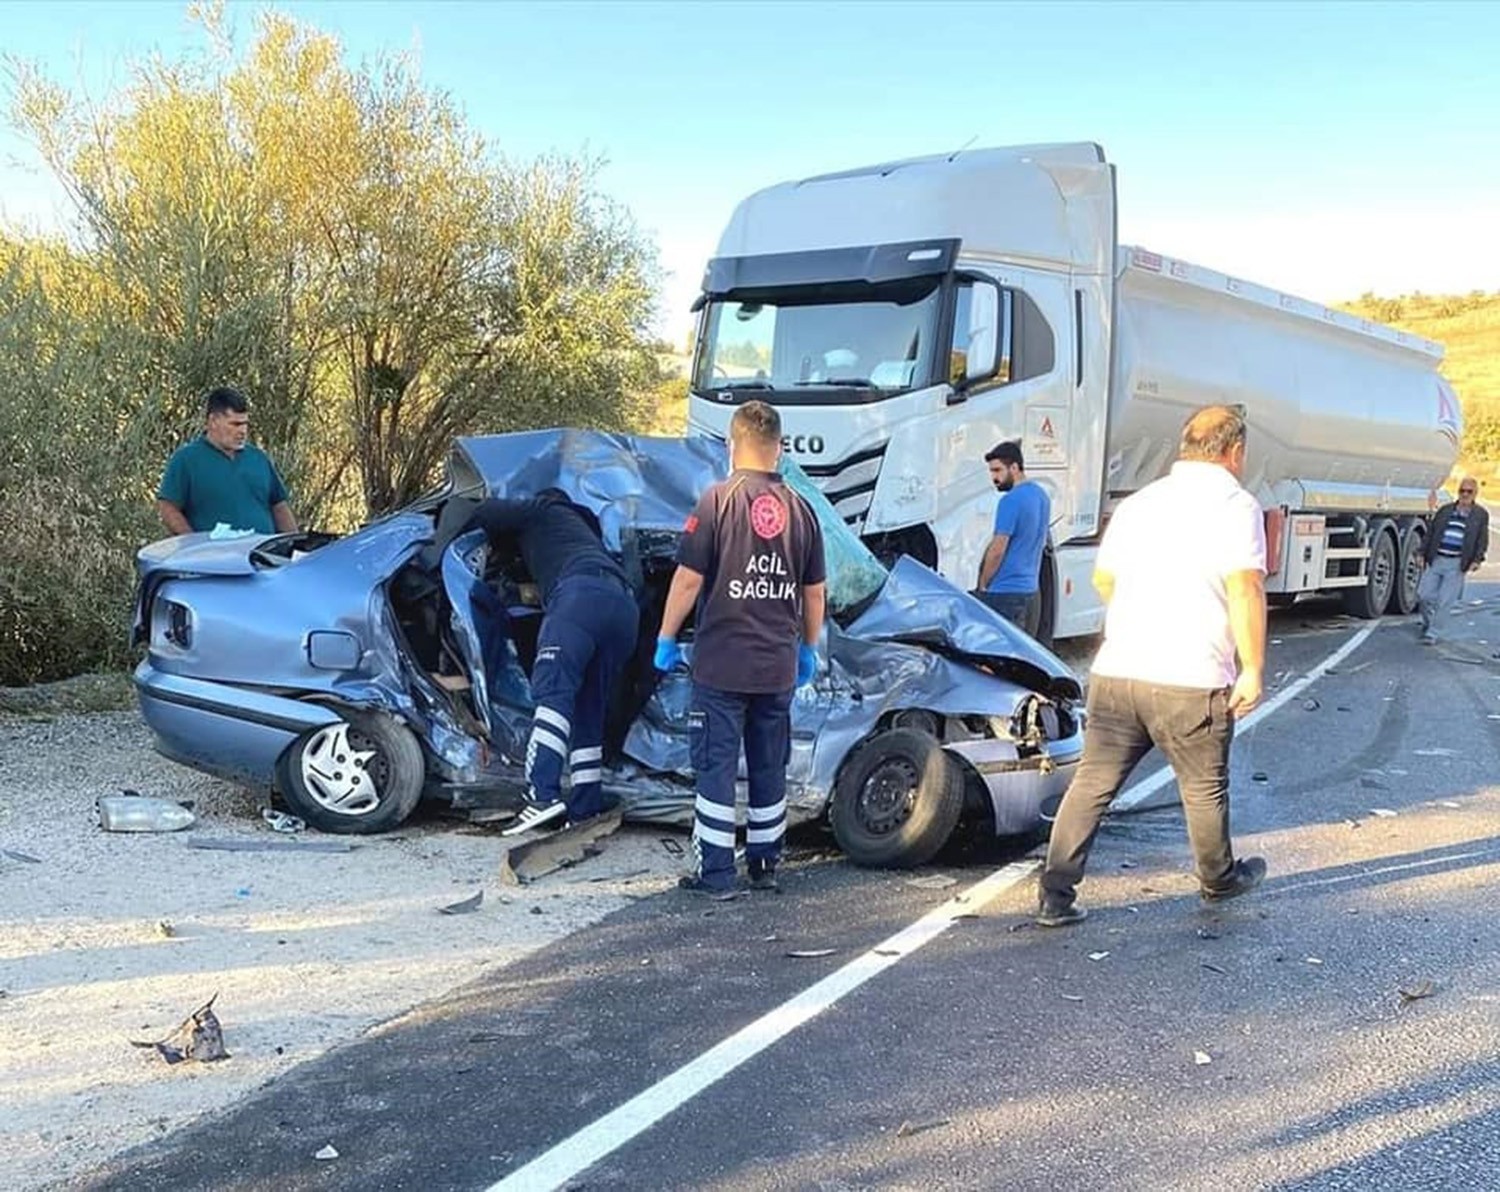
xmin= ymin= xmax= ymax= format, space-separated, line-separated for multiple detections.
xmin=975 ymin=442 xmax=1052 ymax=636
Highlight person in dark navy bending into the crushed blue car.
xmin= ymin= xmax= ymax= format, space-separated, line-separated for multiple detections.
xmin=471 ymin=489 xmax=641 ymax=837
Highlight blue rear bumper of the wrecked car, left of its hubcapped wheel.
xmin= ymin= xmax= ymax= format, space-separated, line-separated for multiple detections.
xmin=135 ymin=660 xmax=339 ymax=787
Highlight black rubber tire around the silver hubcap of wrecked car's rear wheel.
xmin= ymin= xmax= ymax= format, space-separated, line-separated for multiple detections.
xmin=278 ymin=708 xmax=426 ymax=835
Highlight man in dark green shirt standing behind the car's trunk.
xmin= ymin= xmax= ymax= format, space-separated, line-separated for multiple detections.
xmin=156 ymin=388 xmax=297 ymax=534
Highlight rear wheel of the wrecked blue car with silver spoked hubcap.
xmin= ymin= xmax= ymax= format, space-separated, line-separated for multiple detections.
xmin=279 ymin=708 xmax=426 ymax=835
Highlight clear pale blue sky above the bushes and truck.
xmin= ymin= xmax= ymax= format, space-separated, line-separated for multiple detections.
xmin=0 ymin=0 xmax=1500 ymax=339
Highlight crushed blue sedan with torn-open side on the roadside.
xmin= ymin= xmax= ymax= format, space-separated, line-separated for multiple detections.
xmin=135 ymin=430 xmax=1083 ymax=867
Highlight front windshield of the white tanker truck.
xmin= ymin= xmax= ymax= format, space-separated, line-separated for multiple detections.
xmin=693 ymin=277 xmax=942 ymax=403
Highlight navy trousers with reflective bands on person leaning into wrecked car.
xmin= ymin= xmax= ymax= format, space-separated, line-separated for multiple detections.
xmin=527 ymin=574 xmax=641 ymax=820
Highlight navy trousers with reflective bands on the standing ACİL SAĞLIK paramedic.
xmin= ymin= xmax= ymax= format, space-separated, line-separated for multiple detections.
xmin=692 ymin=682 xmax=792 ymax=889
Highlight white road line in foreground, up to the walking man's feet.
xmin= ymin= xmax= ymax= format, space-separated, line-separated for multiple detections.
xmin=488 ymin=861 xmax=1040 ymax=1192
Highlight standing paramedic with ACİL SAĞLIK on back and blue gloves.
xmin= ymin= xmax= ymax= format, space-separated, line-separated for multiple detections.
xmin=656 ymin=402 xmax=825 ymax=894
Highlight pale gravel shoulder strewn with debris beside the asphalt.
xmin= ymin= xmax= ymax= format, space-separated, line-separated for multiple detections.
xmin=0 ymin=707 xmax=686 ymax=1189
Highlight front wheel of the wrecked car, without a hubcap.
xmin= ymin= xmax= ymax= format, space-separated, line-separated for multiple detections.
xmin=828 ymin=729 xmax=963 ymax=870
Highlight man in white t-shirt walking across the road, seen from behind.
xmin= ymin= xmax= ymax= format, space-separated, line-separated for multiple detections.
xmin=1037 ymin=406 xmax=1266 ymax=927
